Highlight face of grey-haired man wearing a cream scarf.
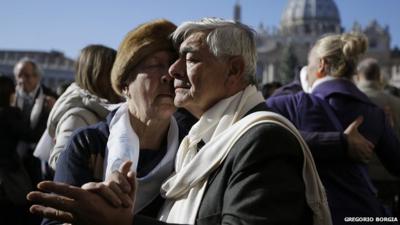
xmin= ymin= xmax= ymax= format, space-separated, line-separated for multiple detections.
xmin=169 ymin=32 xmax=229 ymax=117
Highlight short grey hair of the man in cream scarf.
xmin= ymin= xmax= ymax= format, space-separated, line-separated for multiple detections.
xmin=172 ymin=18 xmax=257 ymax=84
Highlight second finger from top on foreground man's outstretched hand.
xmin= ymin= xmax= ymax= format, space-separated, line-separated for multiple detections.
xmin=26 ymin=191 xmax=75 ymax=212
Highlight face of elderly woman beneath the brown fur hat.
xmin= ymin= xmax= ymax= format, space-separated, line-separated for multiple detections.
xmin=124 ymin=51 xmax=176 ymax=121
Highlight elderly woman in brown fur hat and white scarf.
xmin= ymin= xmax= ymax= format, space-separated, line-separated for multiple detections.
xmin=37 ymin=20 xmax=183 ymax=224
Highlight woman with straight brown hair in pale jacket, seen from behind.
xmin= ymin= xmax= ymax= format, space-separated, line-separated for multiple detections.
xmin=36 ymin=45 xmax=120 ymax=169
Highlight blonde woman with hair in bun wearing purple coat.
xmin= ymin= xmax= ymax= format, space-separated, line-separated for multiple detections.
xmin=267 ymin=34 xmax=400 ymax=224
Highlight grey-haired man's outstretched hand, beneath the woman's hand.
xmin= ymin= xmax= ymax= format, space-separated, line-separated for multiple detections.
xmin=27 ymin=181 xmax=133 ymax=225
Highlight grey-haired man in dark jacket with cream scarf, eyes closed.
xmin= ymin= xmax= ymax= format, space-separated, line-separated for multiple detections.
xmin=28 ymin=18 xmax=331 ymax=224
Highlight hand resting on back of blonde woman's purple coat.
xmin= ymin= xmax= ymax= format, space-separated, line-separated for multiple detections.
xmin=344 ymin=116 xmax=375 ymax=163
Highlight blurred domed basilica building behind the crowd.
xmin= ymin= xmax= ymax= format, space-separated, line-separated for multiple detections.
xmin=238 ymin=0 xmax=400 ymax=87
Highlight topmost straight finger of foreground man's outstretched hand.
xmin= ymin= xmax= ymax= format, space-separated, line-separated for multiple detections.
xmin=37 ymin=181 xmax=85 ymax=199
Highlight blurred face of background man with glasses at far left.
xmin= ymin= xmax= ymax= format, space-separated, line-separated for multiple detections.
xmin=15 ymin=63 xmax=40 ymax=93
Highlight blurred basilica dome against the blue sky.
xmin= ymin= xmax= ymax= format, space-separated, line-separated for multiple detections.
xmin=281 ymin=0 xmax=341 ymax=35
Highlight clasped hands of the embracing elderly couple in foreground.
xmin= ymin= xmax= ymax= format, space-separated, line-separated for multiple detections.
xmin=27 ymin=161 xmax=137 ymax=225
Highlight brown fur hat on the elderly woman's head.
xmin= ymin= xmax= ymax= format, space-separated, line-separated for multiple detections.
xmin=111 ymin=19 xmax=176 ymax=96
